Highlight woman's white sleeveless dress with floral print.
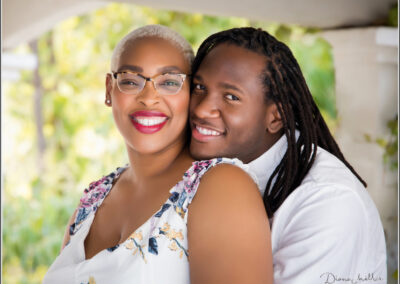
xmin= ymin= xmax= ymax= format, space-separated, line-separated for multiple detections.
xmin=43 ymin=158 xmax=254 ymax=284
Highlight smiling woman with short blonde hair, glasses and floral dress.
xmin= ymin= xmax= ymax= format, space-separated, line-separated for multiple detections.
xmin=44 ymin=25 xmax=272 ymax=284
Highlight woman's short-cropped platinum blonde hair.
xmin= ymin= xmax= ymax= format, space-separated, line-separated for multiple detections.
xmin=111 ymin=25 xmax=194 ymax=72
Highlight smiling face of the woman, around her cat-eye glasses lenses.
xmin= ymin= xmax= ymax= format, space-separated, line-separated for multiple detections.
xmin=106 ymin=37 xmax=190 ymax=153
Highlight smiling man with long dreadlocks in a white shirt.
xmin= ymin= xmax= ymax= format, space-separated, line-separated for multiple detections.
xmin=190 ymin=28 xmax=387 ymax=284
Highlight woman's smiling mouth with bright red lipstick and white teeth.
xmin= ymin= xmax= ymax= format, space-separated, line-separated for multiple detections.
xmin=129 ymin=110 xmax=168 ymax=134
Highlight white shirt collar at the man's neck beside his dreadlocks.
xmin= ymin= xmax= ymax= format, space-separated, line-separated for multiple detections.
xmin=248 ymin=130 xmax=300 ymax=196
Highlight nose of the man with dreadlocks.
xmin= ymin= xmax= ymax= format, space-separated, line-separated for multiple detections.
xmin=190 ymin=94 xmax=220 ymax=119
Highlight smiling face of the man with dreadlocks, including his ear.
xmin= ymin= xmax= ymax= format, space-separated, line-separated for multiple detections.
xmin=190 ymin=44 xmax=281 ymax=163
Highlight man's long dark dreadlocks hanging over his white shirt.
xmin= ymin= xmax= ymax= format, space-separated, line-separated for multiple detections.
xmin=192 ymin=27 xmax=367 ymax=217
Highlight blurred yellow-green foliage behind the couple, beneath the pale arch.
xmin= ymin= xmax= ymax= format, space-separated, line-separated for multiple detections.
xmin=2 ymin=4 xmax=336 ymax=283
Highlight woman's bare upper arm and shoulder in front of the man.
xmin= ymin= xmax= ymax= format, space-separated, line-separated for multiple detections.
xmin=188 ymin=164 xmax=273 ymax=284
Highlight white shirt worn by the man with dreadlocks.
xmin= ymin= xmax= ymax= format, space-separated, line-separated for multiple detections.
xmin=248 ymin=133 xmax=387 ymax=284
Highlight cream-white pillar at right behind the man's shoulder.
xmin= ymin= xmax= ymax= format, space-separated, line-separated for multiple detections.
xmin=322 ymin=27 xmax=398 ymax=283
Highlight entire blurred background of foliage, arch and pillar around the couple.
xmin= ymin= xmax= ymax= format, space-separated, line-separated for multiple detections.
xmin=1 ymin=0 xmax=398 ymax=283
